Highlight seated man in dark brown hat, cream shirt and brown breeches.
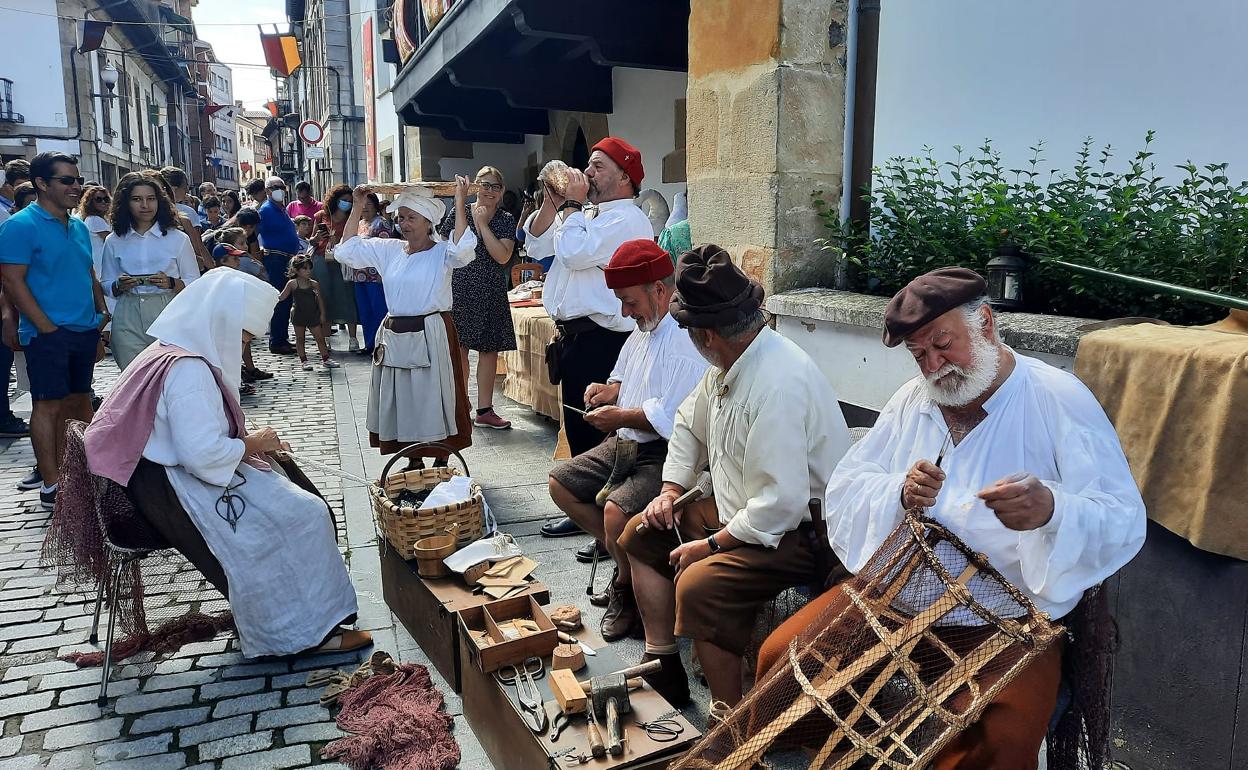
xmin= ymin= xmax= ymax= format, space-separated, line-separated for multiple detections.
xmin=619 ymin=245 xmax=850 ymax=705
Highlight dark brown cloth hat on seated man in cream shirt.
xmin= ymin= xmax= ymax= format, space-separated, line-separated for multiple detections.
xmin=670 ymin=243 xmax=764 ymax=328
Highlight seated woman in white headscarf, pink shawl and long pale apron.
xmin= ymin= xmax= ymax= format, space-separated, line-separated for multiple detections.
xmin=85 ymin=270 xmax=369 ymax=658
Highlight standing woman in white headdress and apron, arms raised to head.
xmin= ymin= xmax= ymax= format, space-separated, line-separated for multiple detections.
xmin=334 ymin=176 xmax=477 ymax=467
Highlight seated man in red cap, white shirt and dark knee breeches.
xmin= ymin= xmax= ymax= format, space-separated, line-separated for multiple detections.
xmin=550 ymin=238 xmax=706 ymax=641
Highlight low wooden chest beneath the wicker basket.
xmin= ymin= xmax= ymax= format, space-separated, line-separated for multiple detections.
xmin=378 ymin=539 xmax=550 ymax=693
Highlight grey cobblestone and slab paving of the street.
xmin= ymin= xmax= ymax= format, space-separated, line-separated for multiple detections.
xmin=0 ymin=334 xmax=706 ymax=770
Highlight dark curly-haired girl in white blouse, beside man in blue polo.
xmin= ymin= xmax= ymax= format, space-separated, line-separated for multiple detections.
xmin=100 ymin=173 xmax=200 ymax=369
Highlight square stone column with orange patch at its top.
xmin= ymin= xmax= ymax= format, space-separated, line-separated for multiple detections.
xmin=686 ymin=0 xmax=849 ymax=292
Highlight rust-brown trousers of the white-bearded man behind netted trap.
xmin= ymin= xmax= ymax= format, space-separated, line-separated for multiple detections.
xmin=755 ymin=588 xmax=1062 ymax=770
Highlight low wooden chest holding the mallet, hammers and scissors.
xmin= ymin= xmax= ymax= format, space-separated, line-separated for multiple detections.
xmin=459 ymin=634 xmax=701 ymax=770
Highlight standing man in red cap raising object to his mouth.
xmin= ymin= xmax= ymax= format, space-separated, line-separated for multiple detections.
xmin=533 ymin=136 xmax=654 ymax=546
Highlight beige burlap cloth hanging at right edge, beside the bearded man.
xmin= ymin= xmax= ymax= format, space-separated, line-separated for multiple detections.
xmin=1075 ymin=324 xmax=1248 ymax=560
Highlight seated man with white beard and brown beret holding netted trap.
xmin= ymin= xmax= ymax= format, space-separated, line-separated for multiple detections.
xmin=759 ymin=267 xmax=1144 ymax=770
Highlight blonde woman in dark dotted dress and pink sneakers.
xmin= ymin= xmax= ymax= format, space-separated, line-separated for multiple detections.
xmin=438 ymin=166 xmax=515 ymax=431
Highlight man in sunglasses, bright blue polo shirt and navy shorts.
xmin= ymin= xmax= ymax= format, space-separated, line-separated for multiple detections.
xmin=0 ymin=152 xmax=109 ymax=510
